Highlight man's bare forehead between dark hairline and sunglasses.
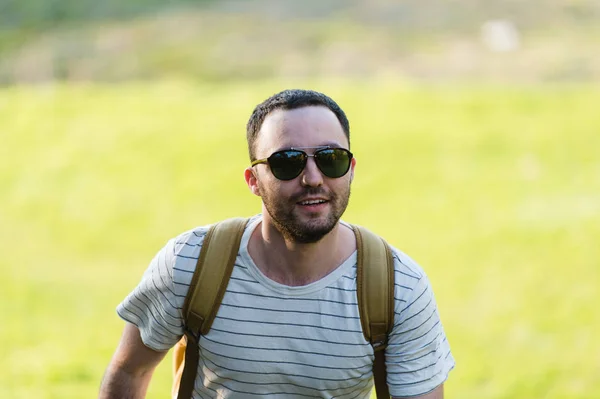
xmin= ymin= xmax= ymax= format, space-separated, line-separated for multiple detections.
xmin=256 ymin=106 xmax=348 ymax=157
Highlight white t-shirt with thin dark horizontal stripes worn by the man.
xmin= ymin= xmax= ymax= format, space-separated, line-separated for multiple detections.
xmin=117 ymin=215 xmax=454 ymax=399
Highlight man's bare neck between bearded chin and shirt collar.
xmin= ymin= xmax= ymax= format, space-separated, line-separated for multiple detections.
xmin=248 ymin=218 xmax=356 ymax=286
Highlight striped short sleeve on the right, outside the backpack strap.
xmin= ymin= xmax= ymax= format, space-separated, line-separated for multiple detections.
xmin=386 ymin=269 xmax=454 ymax=397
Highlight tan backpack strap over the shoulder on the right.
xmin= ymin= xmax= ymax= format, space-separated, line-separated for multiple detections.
xmin=352 ymin=225 xmax=394 ymax=399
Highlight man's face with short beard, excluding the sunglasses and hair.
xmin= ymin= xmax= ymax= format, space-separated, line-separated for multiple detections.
xmin=247 ymin=106 xmax=355 ymax=243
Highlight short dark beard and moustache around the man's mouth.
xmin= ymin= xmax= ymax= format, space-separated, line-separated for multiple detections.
xmin=261 ymin=185 xmax=350 ymax=244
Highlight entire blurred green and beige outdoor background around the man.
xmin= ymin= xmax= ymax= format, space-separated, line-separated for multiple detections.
xmin=0 ymin=0 xmax=600 ymax=399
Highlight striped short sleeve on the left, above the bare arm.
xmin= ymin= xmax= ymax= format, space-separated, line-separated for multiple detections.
xmin=117 ymin=240 xmax=185 ymax=351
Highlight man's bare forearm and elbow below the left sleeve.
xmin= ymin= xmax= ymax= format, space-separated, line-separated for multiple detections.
xmin=98 ymin=323 xmax=167 ymax=399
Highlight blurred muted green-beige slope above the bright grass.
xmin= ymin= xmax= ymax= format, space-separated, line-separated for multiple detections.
xmin=0 ymin=0 xmax=600 ymax=84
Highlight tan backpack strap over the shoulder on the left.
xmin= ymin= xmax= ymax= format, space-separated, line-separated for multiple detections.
xmin=177 ymin=218 xmax=248 ymax=399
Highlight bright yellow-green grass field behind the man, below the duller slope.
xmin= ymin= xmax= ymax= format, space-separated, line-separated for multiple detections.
xmin=0 ymin=81 xmax=600 ymax=399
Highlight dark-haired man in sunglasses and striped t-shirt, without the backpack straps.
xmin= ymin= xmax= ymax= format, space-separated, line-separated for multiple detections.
xmin=100 ymin=90 xmax=454 ymax=399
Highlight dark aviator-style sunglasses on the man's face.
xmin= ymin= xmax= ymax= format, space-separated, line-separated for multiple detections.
xmin=252 ymin=147 xmax=352 ymax=180
